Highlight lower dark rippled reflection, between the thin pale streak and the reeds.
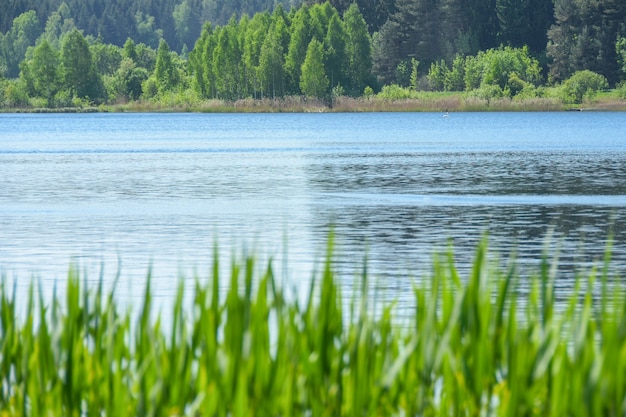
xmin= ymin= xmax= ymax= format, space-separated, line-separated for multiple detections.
xmin=313 ymin=200 xmax=626 ymax=316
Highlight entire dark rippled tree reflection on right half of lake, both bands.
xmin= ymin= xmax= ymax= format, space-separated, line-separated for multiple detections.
xmin=307 ymin=152 xmax=626 ymax=300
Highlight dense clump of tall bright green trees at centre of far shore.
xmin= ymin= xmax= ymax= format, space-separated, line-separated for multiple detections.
xmin=188 ymin=3 xmax=372 ymax=100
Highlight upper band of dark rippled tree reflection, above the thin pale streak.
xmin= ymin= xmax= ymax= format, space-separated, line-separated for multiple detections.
xmin=308 ymin=152 xmax=626 ymax=195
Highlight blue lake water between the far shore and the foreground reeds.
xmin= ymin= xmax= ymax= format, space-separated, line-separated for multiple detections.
xmin=0 ymin=112 xmax=626 ymax=308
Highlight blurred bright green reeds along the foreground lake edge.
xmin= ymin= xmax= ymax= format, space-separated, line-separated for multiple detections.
xmin=0 ymin=236 xmax=626 ymax=417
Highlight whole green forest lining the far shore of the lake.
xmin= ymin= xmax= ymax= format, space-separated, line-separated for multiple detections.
xmin=0 ymin=0 xmax=626 ymax=108
